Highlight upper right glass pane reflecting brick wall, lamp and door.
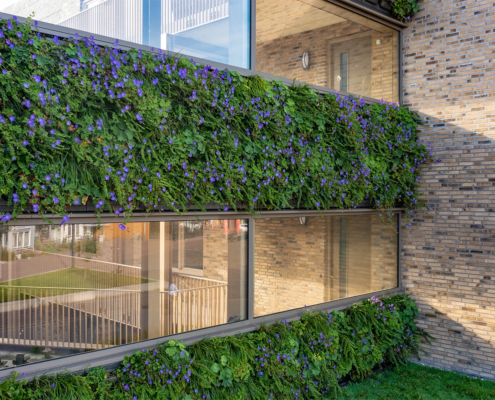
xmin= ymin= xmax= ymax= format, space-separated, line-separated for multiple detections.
xmin=256 ymin=0 xmax=399 ymax=102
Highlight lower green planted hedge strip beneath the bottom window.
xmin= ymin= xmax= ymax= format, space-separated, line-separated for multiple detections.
xmin=0 ymin=295 xmax=429 ymax=400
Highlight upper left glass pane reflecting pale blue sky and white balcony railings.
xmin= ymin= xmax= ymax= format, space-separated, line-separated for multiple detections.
xmin=0 ymin=0 xmax=250 ymax=68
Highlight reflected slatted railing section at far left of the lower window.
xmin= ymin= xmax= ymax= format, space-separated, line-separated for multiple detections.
xmin=0 ymin=286 xmax=141 ymax=349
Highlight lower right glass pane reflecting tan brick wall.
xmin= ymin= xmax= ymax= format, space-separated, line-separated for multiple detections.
xmin=254 ymin=215 xmax=398 ymax=317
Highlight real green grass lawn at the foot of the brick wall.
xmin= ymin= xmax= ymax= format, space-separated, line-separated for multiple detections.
xmin=340 ymin=363 xmax=495 ymax=400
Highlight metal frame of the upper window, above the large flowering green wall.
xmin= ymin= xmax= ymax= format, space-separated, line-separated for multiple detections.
xmin=0 ymin=0 xmax=407 ymax=104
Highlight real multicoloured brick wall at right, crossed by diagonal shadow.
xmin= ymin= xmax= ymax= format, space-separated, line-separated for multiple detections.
xmin=402 ymin=0 xmax=495 ymax=379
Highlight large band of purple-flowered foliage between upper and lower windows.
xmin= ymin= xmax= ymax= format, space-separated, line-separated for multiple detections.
xmin=0 ymin=20 xmax=429 ymax=229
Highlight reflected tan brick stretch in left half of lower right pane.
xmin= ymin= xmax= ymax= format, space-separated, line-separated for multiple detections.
xmin=254 ymin=218 xmax=326 ymax=317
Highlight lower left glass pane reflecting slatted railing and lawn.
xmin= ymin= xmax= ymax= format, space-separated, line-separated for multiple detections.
xmin=0 ymin=220 xmax=247 ymax=367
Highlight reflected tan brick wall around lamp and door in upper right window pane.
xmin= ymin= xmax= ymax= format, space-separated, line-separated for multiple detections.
xmin=256 ymin=21 xmax=398 ymax=101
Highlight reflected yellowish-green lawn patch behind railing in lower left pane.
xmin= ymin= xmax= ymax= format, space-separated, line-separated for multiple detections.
xmin=0 ymin=267 xmax=148 ymax=303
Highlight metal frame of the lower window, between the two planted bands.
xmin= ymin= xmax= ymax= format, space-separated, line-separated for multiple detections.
xmin=0 ymin=208 xmax=404 ymax=379
